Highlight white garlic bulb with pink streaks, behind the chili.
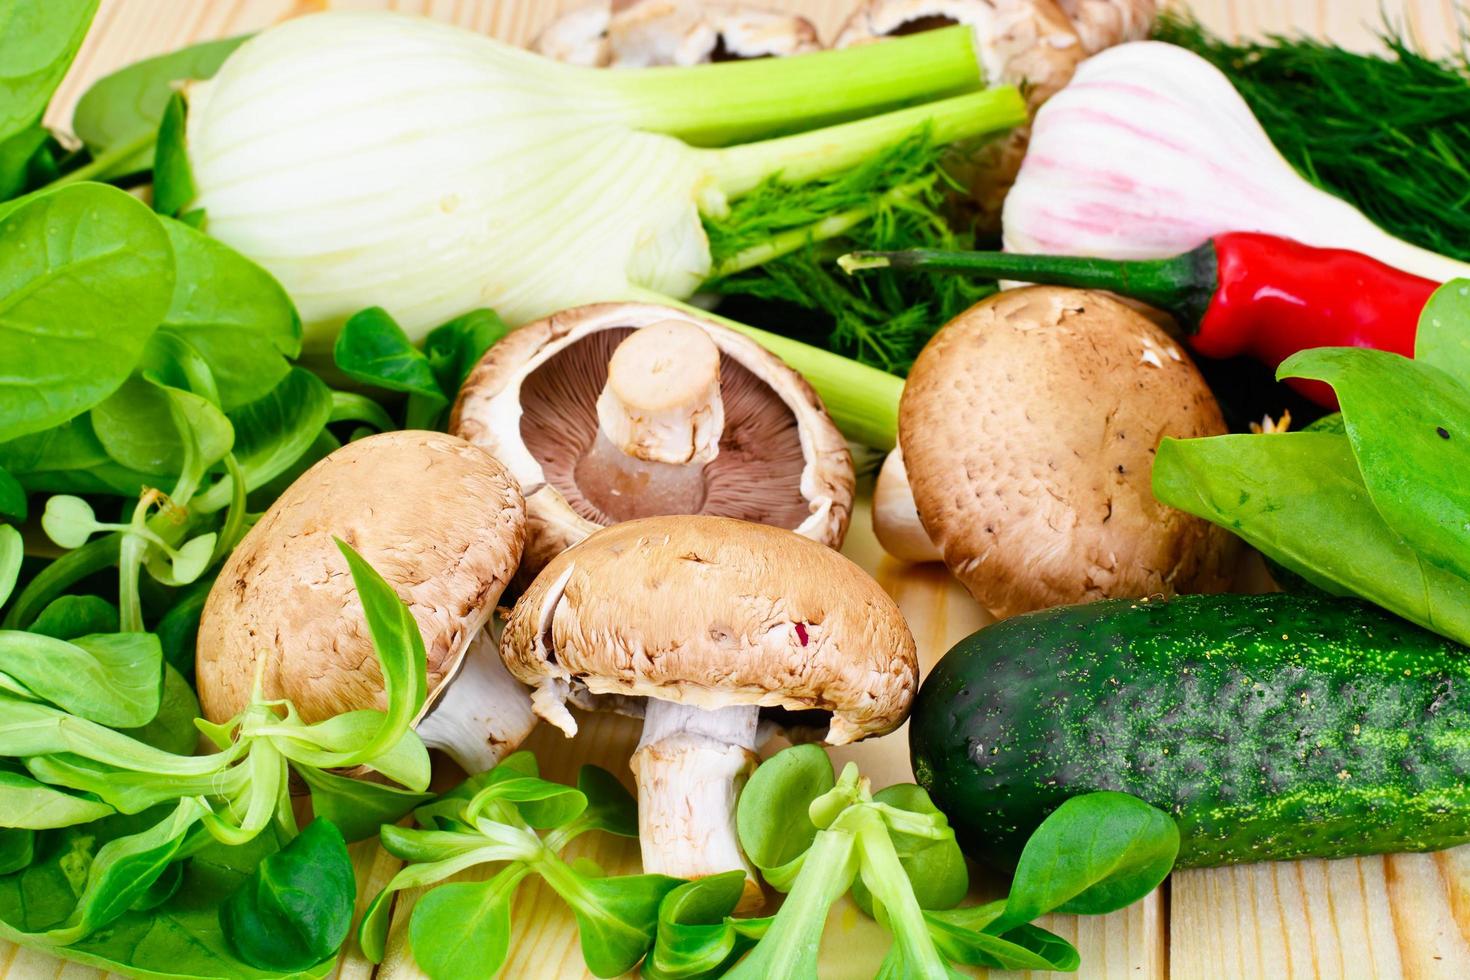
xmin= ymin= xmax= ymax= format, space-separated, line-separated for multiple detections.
xmin=1003 ymin=41 xmax=1470 ymax=281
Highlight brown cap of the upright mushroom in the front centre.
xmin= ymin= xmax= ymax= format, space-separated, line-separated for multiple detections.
xmin=500 ymin=517 xmax=919 ymax=745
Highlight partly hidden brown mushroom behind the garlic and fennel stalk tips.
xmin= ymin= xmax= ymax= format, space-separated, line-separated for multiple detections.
xmin=833 ymin=0 xmax=1157 ymax=232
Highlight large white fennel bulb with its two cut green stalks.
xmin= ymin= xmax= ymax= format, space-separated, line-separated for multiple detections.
xmin=187 ymin=13 xmax=1025 ymax=353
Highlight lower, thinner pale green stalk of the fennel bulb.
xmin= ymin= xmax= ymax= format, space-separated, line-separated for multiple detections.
xmin=704 ymin=88 xmax=1026 ymax=198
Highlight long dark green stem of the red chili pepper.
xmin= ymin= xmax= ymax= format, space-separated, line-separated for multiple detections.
xmin=836 ymin=242 xmax=1219 ymax=334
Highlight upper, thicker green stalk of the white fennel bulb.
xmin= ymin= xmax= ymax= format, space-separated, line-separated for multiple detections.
xmin=602 ymin=26 xmax=982 ymax=145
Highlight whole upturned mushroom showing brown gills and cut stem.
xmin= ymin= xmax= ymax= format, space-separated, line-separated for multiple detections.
xmin=450 ymin=304 xmax=854 ymax=580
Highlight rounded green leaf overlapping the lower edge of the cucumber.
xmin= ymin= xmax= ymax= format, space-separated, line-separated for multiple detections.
xmin=991 ymin=792 xmax=1179 ymax=933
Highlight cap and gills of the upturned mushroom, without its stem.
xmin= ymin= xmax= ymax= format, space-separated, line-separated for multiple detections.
xmin=450 ymin=303 xmax=854 ymax=579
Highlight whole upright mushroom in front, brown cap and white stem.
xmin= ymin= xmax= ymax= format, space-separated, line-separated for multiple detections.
xmin=500 ymin=517 xmax=919 ymax=908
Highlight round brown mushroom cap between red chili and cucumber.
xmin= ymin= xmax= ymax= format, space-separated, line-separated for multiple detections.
xmin=898 ymin=287 xmax=1235 ymax=617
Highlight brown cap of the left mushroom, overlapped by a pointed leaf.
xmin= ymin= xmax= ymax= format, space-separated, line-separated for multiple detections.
xmin=196 ymin=430 xmax=525 ymax=723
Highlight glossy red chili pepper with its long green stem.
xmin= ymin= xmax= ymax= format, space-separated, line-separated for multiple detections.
xmin=844 ymin=232 xmax=1439 ymax=407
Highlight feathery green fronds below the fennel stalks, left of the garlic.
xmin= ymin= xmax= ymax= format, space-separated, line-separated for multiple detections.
xmin=704 ymin=131 xmax=995 ymax=375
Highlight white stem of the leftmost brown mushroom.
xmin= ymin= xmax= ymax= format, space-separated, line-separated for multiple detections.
xmin=416 ymin=626 xmax=537 ymax=776
